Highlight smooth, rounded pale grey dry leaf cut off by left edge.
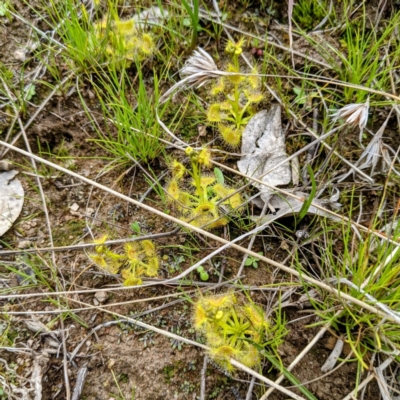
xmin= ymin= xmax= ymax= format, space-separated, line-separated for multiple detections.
xmin=0 ymin=170 xmax=24 ymax=236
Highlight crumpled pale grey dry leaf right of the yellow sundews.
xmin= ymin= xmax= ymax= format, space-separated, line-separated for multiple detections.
xmin=238 ymin=105 xmax=291 ymax=203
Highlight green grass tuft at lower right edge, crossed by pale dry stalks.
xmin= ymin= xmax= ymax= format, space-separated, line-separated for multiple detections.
xmin=299 ymin=217 xmax=400 ymax=369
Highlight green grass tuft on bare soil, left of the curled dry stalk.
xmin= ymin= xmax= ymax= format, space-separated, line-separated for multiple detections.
xmin=82 ymin=69 xmax=167 ymax=164
